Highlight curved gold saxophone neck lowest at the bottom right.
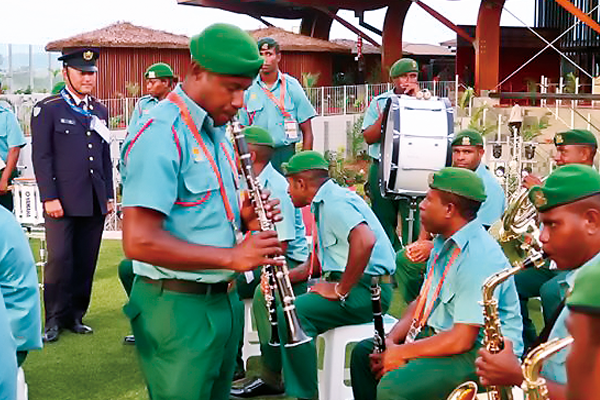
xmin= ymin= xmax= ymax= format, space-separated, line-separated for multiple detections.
xmin=521 ymin=336 xmax=573 ymax=400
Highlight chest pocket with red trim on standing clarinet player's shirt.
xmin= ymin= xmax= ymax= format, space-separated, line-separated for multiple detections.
xmin=175 ymin=161 xmax=219 ymax=207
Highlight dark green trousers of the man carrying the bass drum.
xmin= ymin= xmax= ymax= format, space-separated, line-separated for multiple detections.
xmin=368 ymin=160 xmax=422 ymax=251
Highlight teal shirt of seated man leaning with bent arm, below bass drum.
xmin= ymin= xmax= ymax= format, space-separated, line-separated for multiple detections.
xmin=311 ymin=179 xmax=396 ymax=275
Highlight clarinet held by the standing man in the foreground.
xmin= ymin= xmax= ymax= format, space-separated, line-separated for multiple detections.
xmin=228 ymin=118 xmax=311 ymax=347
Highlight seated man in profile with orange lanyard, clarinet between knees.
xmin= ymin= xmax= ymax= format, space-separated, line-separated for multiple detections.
xmin=351 ymin=167 xmax=522 ymax=400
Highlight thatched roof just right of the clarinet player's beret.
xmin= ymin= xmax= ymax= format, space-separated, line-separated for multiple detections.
xmin=250 ymin=27 xmax=350 ymax=53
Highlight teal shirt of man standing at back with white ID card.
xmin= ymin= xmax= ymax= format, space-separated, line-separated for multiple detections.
xmin=239 ymin=72 xmax=317 ymax=147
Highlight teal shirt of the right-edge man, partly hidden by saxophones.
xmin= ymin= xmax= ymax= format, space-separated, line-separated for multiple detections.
xmin=541 ymin=253 xmax=600 ymax=385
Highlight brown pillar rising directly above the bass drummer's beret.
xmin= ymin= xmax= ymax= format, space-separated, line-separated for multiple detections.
xmin=381 ymin=1 xmax=412 ymax=82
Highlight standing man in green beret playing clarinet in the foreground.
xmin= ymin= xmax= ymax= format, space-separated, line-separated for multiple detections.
xmin=122 ymin=24 xmax=281 ymax=400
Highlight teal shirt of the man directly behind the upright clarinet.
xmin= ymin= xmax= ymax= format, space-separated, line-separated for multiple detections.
xmin=258 ymin=163 xmax=308 ymax=263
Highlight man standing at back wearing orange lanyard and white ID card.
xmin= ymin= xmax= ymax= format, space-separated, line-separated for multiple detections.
xmin=240 ymin=37 xmax=317 ymax=172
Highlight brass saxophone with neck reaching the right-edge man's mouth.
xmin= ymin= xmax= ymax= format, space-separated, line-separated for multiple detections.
xmin=447 ymin=252 xmax=545 ymax=400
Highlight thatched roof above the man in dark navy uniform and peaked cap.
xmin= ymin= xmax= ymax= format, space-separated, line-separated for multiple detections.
xmin=46 ymin=22 xmax=190 ymax=51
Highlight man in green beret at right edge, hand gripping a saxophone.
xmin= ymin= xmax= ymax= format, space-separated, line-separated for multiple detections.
xmin=476 ymin=164 xmax=600 ymax=400
